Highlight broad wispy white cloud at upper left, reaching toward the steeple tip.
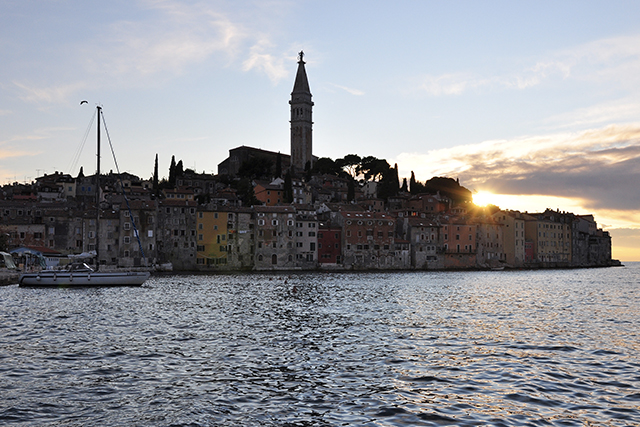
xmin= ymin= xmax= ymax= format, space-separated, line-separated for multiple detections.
xmin=13 ymin=0 xmax=289 ymax=104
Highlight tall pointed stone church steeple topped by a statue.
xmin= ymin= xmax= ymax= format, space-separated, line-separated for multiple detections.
xmin=289 ymin=51 xmax=313 ymax=171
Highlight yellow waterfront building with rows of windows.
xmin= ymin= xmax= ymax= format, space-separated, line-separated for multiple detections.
xmin=196 ymin=210 xmax=229 ymax=267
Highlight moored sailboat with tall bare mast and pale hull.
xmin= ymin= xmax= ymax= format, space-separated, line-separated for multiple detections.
xmin=19 ymin=106 xmax=151 ymax=287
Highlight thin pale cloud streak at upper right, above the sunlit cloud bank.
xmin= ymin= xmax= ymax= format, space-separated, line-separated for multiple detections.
xmin=417 ymin=35 xmax=640 ymax=96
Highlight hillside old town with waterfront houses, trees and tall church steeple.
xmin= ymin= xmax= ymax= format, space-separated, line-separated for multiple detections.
xmin=0 ymin=52 xmax=615 ymax=271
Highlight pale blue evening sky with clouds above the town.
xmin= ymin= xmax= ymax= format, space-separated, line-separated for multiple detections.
xmin=0 ymin=0 xmax=640 ymax=261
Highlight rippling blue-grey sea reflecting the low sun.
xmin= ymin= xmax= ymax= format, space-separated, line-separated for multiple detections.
xmin=0 ymin=263 xmax=640 ymax=426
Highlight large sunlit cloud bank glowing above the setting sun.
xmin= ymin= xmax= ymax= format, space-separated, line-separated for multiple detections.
xmin=397 ymin=123 xmax=640 ymax=211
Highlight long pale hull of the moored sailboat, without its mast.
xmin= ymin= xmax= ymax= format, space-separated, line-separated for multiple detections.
xmin=19 ymin=271 xmax=151 ymax=288
